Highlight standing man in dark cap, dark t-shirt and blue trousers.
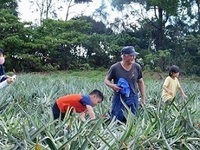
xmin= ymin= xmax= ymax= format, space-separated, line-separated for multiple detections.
xmin=104 ymin=46 xmax=146 ymax=123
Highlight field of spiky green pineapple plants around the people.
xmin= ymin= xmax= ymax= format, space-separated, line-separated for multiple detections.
xmin=0 ymin=71 xmax=200 ymax=150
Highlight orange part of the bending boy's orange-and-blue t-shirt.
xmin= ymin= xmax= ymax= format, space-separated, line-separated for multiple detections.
xmin=56 ymin=94 xmax=87 ymax=113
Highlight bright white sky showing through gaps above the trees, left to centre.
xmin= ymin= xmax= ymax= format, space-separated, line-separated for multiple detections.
xmin=18 ymin=0 xmax=148 ymax=32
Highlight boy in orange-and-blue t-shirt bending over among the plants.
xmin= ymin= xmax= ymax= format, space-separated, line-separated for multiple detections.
xmin=52 ymin=89 xmax=104 ymax=121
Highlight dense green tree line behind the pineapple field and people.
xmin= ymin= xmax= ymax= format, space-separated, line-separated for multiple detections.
xmin=0 ymin=0 xmax=200 ymax=75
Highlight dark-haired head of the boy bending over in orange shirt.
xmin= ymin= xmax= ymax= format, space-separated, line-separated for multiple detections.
xmin=89 ymin=89 xmax=104 ymax=106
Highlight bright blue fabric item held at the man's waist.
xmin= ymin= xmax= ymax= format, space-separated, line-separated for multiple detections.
xmin=117 ymin=78 xmax=131 ymax=97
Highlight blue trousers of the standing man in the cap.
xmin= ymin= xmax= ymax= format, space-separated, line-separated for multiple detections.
xmin=111 ymin=93 xmax=138 ymax=122
